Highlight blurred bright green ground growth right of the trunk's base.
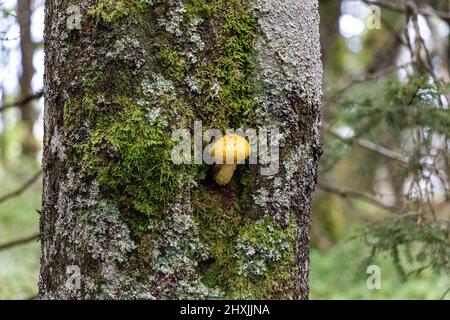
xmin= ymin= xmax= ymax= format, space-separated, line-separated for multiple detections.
xmin=310 ymin=229 xmax=450 ymax=300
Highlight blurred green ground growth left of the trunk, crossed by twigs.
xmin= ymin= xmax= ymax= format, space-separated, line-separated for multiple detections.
xmin=0 ymin=169 xmax=42 ymax=300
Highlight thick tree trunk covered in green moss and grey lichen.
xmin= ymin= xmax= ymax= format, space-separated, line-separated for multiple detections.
xmin=39 ymin=0 xmax=322 ymax=299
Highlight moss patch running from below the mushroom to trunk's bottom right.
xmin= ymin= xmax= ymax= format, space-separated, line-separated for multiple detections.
xmin=192 ymin=187 xmax=296 ymax=299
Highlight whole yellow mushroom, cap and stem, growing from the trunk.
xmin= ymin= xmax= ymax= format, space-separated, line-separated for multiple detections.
xmin=211 ymin=134 xmax=250 ymax=186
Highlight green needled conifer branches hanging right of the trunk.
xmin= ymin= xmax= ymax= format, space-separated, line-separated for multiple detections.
xmin=322 ymin=58 xmax=450 ymax=292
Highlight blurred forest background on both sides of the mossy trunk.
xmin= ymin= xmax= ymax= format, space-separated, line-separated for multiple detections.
xmin=0 ymin=0 xmax=450 ymax=299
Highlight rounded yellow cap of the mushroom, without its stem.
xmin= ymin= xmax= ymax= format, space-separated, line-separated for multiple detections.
xmin=211 ymin=134 xmax=250 ymax=164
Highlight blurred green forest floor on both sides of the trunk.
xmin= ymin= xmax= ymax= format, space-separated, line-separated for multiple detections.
xmin=0 ymin=166 xmax=450 ymax=299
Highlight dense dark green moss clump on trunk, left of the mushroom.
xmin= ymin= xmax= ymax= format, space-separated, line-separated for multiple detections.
xmin=84 ymin=98 xmax=191 ymax=228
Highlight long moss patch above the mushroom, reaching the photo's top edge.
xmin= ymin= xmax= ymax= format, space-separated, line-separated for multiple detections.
xmin=149 ymin=0 xmax=258 ymax=130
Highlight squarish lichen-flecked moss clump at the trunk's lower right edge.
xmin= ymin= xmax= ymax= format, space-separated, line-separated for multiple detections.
xmin=228 ymin=216 xmax=297 ymax=299
